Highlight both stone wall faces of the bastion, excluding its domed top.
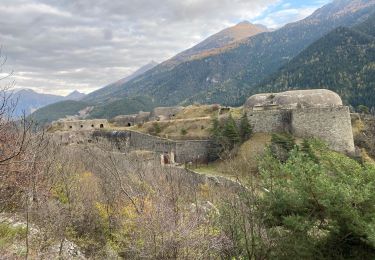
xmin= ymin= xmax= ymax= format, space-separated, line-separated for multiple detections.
xmin=247 ymin=106 xmax=355 ymax=153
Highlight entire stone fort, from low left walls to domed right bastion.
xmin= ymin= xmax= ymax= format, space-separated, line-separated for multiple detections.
xmin=52 ymin=89 xmax=355 ymax=159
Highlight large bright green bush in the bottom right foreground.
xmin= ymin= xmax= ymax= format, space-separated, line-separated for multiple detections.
xmin=259 ymin=141 xmax=375 ymax=259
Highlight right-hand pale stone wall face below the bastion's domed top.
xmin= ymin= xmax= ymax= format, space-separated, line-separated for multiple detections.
xmin=292 ymin=107 xmax=355 ymax=153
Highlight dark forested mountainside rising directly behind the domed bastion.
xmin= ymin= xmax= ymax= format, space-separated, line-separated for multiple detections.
xmin=254 ymin=11 xmax=375 ymax=107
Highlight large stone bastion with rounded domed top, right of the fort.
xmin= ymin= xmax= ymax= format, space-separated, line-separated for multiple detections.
xmin=244 ymin=89 xmax=355 ymax=154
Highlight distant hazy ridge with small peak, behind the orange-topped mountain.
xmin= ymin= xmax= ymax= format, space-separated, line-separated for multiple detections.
xmin=84 ymin=61 xmax=158 ymax=102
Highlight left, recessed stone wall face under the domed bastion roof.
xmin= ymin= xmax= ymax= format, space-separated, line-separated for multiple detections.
xmin=247 ymin=109 xmax=291 ymax=133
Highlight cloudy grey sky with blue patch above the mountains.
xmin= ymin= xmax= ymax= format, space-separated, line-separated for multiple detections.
xmin=0 ymin=0 xmax=330 ymax=95
